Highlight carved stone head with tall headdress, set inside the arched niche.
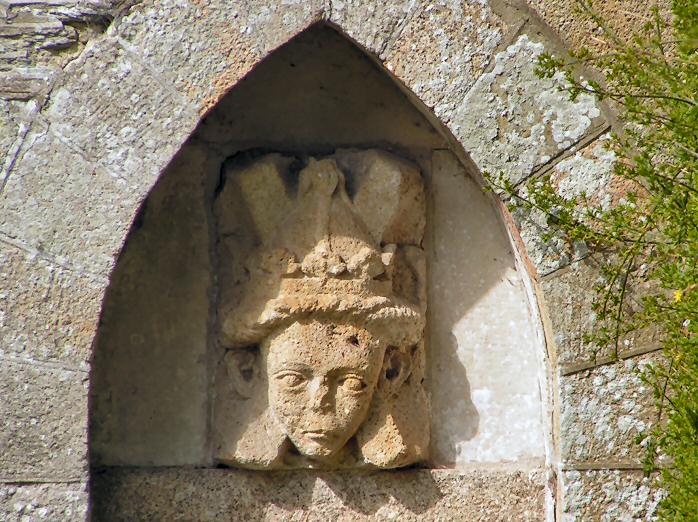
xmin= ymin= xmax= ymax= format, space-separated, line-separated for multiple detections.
xmin=213 ymin=150 xmax=429 ymax=469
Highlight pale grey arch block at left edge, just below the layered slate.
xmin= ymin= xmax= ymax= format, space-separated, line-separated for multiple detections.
xmin=0 ymin=120 xmax=141 ymax=274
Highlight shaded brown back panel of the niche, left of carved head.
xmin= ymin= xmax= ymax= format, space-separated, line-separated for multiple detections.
xmin=90 ymin=143 xmax=213 ymax=465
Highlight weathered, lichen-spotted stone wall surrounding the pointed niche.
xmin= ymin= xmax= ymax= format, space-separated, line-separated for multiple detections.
xmin=0 ymin=0 xmax=660 ymax=520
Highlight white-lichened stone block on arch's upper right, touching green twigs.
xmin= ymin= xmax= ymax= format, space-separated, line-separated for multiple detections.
xmin=449 ymin=35 xmax=600 ymax=187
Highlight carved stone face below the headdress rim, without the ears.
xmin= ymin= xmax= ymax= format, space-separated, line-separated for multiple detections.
xmin=262 ymin=321 xmax=386 ymax=460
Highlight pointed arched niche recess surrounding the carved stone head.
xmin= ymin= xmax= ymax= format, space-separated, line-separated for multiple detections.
xmin=90 ymin=19 xmax=549 ymax=516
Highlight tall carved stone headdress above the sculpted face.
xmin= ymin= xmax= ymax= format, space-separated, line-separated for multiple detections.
xmin=217 ymin=150 xmax=425 ymax=348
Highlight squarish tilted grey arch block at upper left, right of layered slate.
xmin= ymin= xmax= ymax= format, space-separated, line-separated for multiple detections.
xmin=42 ymin=39 xmax=198 ymax=181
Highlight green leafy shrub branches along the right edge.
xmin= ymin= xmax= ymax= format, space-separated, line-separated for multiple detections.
xmin=490 ymin=0 xmax=698 ymax=521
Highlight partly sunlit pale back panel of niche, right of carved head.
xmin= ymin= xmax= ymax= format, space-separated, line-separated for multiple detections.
xmin=427 ymin=151 xmax=549 ymax=468
